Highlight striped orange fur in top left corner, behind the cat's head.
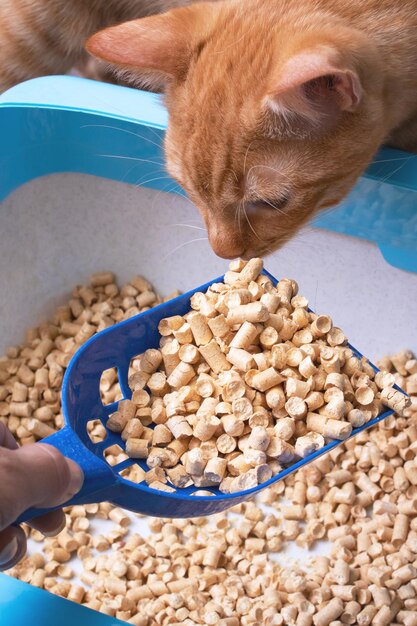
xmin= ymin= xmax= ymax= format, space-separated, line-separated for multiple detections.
xmin=0 ymin=0 xmax=187 ymax=93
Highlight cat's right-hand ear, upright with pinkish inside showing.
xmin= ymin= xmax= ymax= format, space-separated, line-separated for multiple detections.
xmin=266 ymin=46 xmax=363 ymax=126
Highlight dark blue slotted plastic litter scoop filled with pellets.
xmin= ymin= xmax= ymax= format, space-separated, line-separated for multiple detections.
xmin=17 ymin=271 xmax=393 ymax=523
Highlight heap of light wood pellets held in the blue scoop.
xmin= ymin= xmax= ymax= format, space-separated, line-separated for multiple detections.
xmin=107 ymin=258 xmax=408 ymax=495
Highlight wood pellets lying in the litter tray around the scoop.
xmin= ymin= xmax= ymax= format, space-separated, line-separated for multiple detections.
xmin=0 ymin=272 xmax=417 ymax=626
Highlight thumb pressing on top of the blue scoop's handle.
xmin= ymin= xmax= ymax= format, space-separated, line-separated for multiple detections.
xmin=0 ymin=443 xmax=84 ymax=530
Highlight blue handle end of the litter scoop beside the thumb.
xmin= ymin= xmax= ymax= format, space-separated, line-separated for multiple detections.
xmin=16 ymin=426 xmax=117 ymax=524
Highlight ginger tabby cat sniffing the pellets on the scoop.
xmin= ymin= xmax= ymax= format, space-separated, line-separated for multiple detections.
xmin=0 ymin=0 xmax=417 ymax=258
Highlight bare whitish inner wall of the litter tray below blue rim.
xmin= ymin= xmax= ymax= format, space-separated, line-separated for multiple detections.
xmin=0 ymin=174 xmax=417 ymax=359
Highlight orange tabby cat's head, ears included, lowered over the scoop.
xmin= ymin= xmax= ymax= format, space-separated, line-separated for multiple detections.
xmin=87 ymin=0 xmax=384 ymax=258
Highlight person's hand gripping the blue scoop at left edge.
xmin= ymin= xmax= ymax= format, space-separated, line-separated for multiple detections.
xmin=0 ymin=422 xmax=84 ymax=570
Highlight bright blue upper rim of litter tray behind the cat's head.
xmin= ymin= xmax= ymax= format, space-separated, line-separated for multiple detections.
xmin=0 ymin=76 xmax=417 ymax=272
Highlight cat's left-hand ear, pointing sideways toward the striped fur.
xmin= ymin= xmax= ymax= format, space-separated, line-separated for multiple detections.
xmin=86 ymin=7 xmax=202 ymax=82
